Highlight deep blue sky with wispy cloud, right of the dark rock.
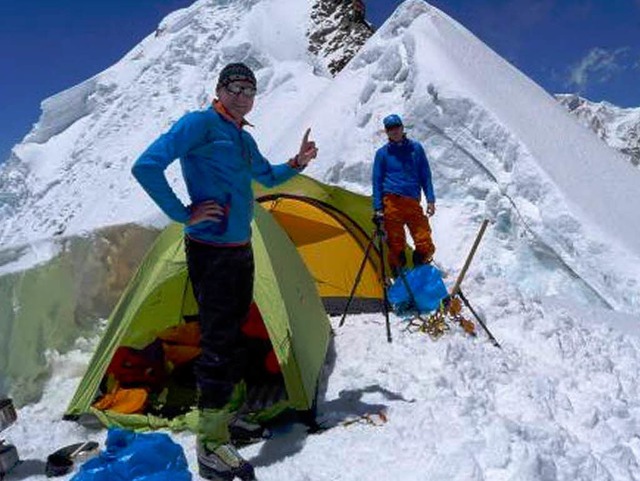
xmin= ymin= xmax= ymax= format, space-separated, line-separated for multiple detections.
xmin=367 ymin=0 xmax=640 ymax=107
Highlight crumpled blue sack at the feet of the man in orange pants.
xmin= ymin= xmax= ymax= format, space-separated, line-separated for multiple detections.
xmin=387 ymin=264 xmax=449 ymax=313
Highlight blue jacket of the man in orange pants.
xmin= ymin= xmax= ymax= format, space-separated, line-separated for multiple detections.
xmin=373 ymin=138 xmax=436 ymax=210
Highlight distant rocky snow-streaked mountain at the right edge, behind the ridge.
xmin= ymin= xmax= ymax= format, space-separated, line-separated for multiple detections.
xmin=556 ymin=94 xmax=640 ymax=166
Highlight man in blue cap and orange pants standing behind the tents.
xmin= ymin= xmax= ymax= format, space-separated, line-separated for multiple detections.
xmin=372 ymin=114 xmax=436 ymax=275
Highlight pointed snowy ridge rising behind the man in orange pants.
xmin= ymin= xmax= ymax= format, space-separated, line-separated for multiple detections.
xmin=268 ymin=0 xmax=640 ymax=310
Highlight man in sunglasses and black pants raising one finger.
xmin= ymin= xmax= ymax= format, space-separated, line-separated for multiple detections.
xmin=132 ymin=63 xmax=318 ymax=480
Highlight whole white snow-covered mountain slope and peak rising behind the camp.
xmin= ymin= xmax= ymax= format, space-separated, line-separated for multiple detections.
xmin=0 ymin=0 xmax=640 ymax=388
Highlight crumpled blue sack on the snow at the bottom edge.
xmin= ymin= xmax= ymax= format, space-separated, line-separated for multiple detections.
xmin=71 ymin=429 xmax=191 ymax=481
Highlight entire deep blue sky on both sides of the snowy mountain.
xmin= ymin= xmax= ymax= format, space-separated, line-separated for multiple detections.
xmin=0 ymin=0 xmax=640 ymax=162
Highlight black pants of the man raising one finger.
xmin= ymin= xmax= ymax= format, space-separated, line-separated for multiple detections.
xmin=185 ymin=238 xmax=254 ymax=409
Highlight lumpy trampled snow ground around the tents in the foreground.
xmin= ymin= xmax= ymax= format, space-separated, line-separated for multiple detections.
xmin=3 ymin=281 xmax=640 ymax=481
